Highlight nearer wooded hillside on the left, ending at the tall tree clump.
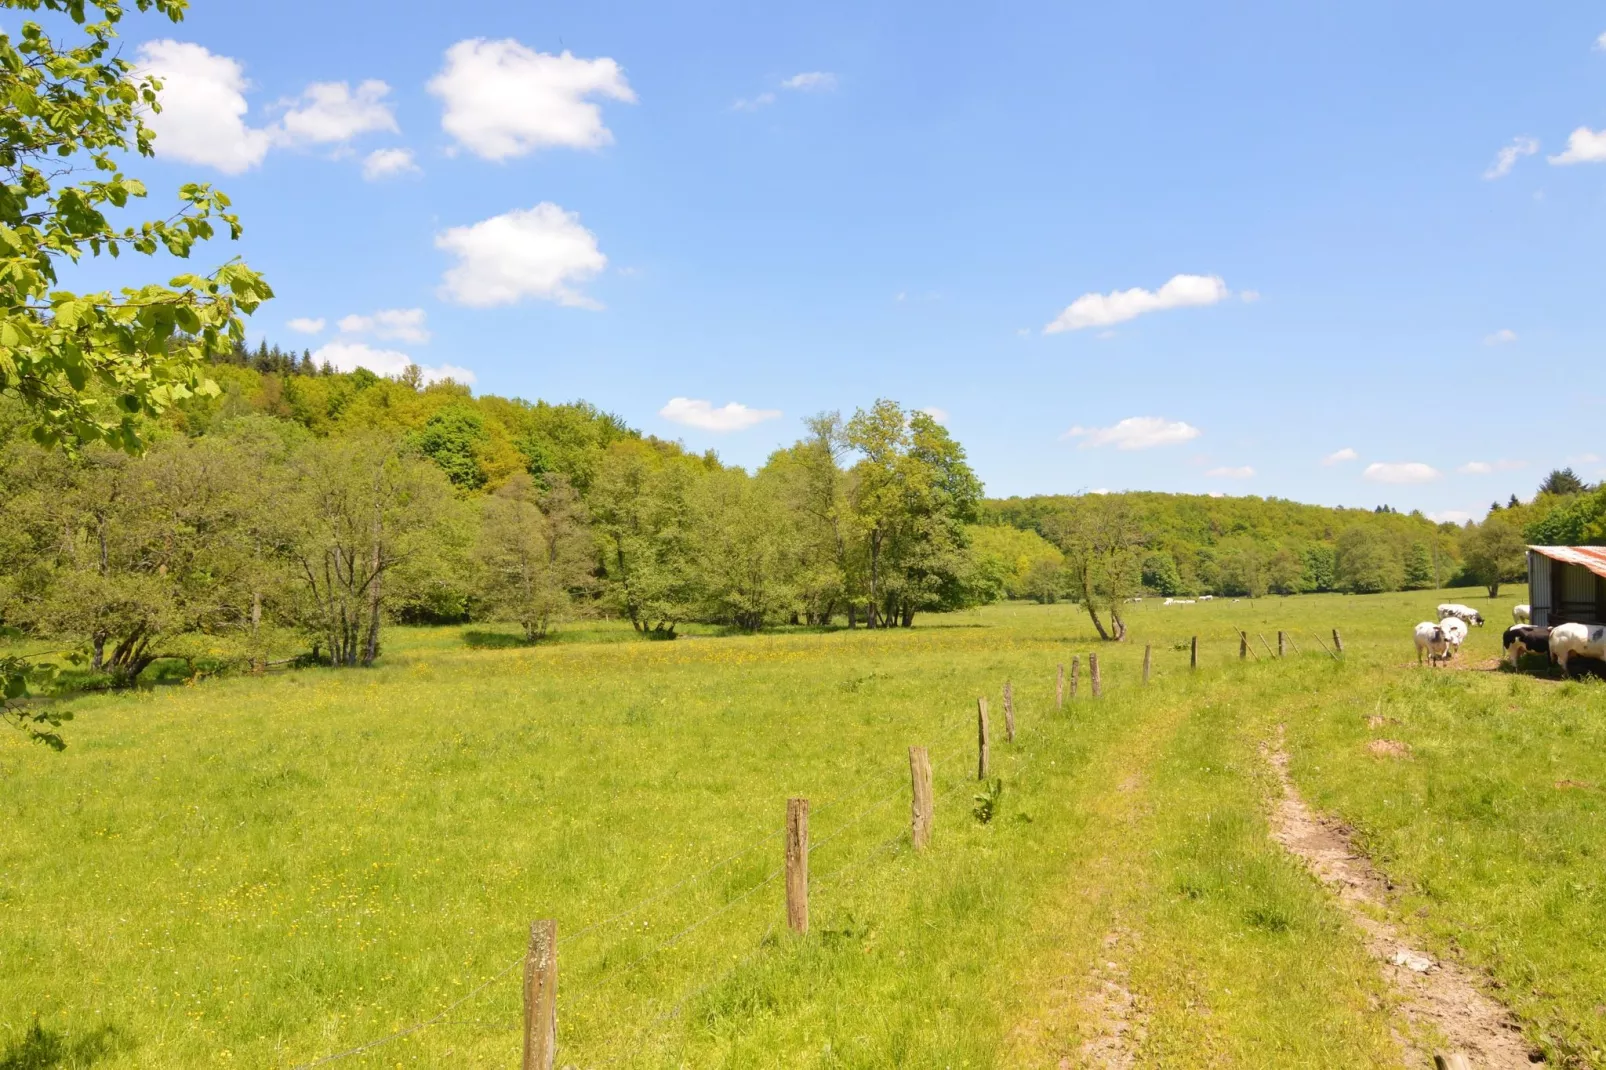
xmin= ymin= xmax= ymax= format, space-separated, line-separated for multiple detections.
xmin=0 ymin=361 xmax=981 ymax=684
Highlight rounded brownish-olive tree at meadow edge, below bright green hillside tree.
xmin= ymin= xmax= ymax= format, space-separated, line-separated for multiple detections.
xmin=475 ymin=472 xmax=594 ymax=643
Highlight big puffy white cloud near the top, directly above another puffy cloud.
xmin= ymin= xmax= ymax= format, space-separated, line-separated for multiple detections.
xmin=429 ymin=37 xmax=636 ymax=159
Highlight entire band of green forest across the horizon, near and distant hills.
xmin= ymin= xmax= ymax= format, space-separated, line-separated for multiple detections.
xmin=0 ymin=344 xmax=1606 ymax=684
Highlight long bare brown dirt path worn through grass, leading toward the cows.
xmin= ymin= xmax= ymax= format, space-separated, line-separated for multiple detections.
xmin=1262 ymin=729 xmax=1542 ymax=1070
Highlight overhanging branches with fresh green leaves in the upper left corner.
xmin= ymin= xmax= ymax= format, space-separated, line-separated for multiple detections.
xmin=0 ymin=0 xmax=273 ymax=451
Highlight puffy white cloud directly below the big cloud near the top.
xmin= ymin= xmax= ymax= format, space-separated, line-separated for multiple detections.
xmin=435 ymin=201 xmax=607 ymax=308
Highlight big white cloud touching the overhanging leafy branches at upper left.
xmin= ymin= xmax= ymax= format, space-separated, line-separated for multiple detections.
xmin=138 ymin=40 xmax=273 ymax=175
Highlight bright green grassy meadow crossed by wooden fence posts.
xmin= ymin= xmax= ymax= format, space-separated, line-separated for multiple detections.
xmin=0 ymin=588 xmax=1606 ymax=1070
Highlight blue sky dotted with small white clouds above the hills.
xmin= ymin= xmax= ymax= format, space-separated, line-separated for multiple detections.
xmin=56 ymin=0 xmax=1606 ymax=517
